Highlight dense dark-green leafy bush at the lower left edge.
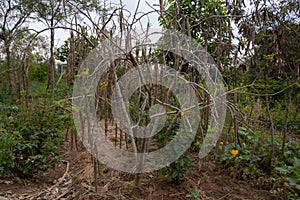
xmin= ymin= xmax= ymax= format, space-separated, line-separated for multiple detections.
xmin=0 ymin=105 xmax=70 ymax=178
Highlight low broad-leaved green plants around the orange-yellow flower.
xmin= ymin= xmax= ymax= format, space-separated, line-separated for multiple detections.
xmin=220 ymin=127 xmax=300 ymax=199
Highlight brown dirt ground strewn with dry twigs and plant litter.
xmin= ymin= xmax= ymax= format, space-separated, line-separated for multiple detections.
xmin=0 ymin=139 xmax=271 ymax=200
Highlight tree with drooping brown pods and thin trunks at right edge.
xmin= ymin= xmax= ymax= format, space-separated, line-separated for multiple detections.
xmin=242 ymin=1 xmax=300 ymax=160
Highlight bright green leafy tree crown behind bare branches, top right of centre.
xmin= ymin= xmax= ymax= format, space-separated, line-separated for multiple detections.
xmin=159 ymin=0 xmax=231 ymax=64
